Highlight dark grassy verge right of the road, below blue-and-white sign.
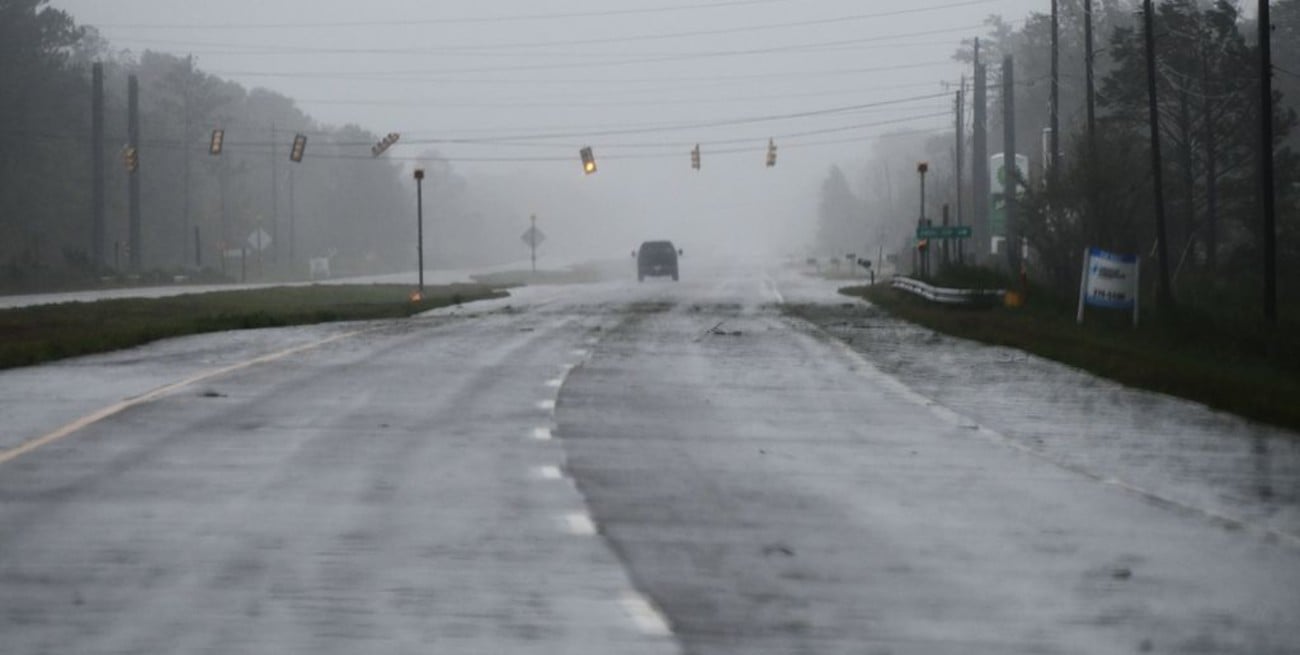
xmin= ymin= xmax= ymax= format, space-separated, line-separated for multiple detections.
xmin=841 ymin=285 xmax=1300 ymax=430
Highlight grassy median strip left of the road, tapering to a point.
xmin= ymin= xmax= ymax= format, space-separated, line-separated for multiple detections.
xmin=0 ymin=285 xmax=506 ymax=369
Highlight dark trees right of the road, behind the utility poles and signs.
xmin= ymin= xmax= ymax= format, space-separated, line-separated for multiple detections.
xmin=819 ymin=0 xmax=1300 ymax=315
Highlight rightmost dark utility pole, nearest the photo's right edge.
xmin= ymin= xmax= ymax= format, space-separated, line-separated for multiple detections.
xmin=1258 ymin=0 xmax=1278 ymax=324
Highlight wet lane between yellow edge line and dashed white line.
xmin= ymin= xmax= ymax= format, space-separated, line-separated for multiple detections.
xmin=0 ymin=284 xmax=675 ymax=654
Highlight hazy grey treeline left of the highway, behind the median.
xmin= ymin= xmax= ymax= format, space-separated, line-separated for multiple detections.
xmin=0 ymin=0 xmax=514 ymax=290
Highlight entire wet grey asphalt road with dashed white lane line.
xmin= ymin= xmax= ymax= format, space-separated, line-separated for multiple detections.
xmin=0 ymin=263 xmax=1300 ymax=654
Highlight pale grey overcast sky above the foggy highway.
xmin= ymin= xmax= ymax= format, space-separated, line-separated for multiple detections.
xmin=51 ymin=0 xmax=1048 ymax=258
